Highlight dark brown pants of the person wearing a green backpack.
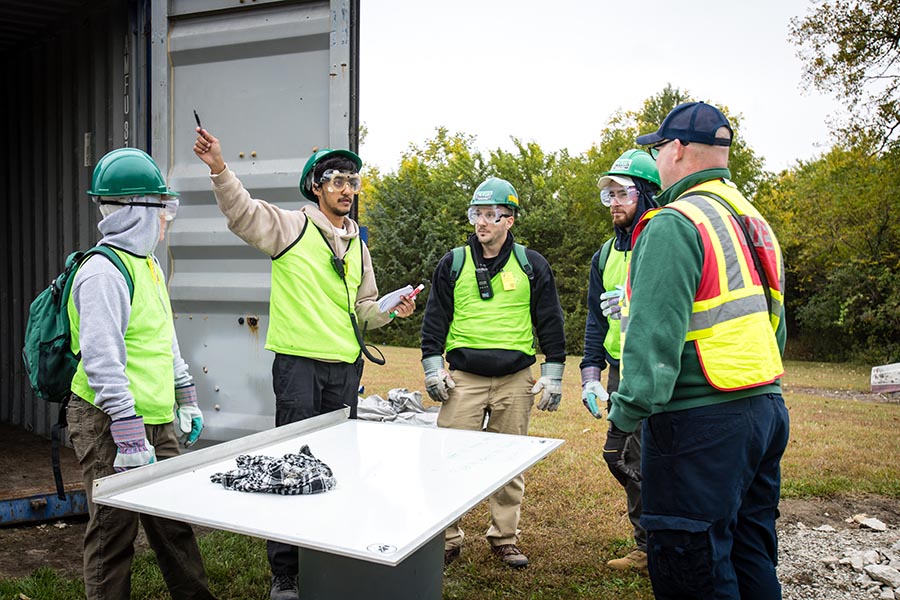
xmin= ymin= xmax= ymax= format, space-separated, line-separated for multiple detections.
xmin=68 ymin=394 xmax=213 ymax=600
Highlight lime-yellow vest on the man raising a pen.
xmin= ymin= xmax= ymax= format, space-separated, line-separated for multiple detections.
xmin=266 ymin=220 xmax=362 ymax=363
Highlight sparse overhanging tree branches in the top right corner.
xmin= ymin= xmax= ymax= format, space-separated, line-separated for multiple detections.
xmin=790 ymin=0 xmax=900 ymax=149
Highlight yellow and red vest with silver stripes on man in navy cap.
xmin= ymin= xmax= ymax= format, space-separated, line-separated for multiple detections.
xmin=622 ymin=180 xmax=784 ymax=391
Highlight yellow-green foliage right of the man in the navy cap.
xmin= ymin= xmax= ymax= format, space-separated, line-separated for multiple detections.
xmin=757 ymin=145 xmax=900 ymax=362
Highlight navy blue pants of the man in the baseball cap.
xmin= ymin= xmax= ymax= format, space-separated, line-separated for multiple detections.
xmin=641 ymin=394 xmax=789 ymax=600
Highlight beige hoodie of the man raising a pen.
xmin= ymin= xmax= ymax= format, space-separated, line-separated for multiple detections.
xmin=210 ymin=166 xmax=391 ymax=329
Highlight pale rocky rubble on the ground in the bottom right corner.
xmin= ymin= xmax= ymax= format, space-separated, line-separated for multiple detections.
xmin=778 ymin=514 xmax=900 ymax=600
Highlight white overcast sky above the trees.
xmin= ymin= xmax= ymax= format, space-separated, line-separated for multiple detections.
xmin=360 ymin=0 xmax=839 ymax=176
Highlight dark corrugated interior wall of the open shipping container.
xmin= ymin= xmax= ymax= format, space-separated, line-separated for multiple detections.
xmin=0 ymin=1 xmax=140 ymax=436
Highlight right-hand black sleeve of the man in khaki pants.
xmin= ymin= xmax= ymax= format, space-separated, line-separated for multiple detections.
xmin=525 ymin=249 xmax=566 ymax=363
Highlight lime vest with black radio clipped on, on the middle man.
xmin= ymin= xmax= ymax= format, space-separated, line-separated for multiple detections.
xmin=447 ymin=245 xmax=535 ymax=356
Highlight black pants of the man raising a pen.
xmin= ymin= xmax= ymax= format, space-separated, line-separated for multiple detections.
xmin=266 ymin=354 xmax=363 ymax=577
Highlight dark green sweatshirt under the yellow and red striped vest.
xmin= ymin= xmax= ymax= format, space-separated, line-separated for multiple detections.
xmin=609 ymin=169 xmax=787 ymax=432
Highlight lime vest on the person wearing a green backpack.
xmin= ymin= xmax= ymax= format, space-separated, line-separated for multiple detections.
xmin=67 ymin=248 xmax=175 ymax=425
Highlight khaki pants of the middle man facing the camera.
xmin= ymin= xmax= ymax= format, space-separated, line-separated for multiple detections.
xmin=438 ymin=369 xmax=534 ymax=550
